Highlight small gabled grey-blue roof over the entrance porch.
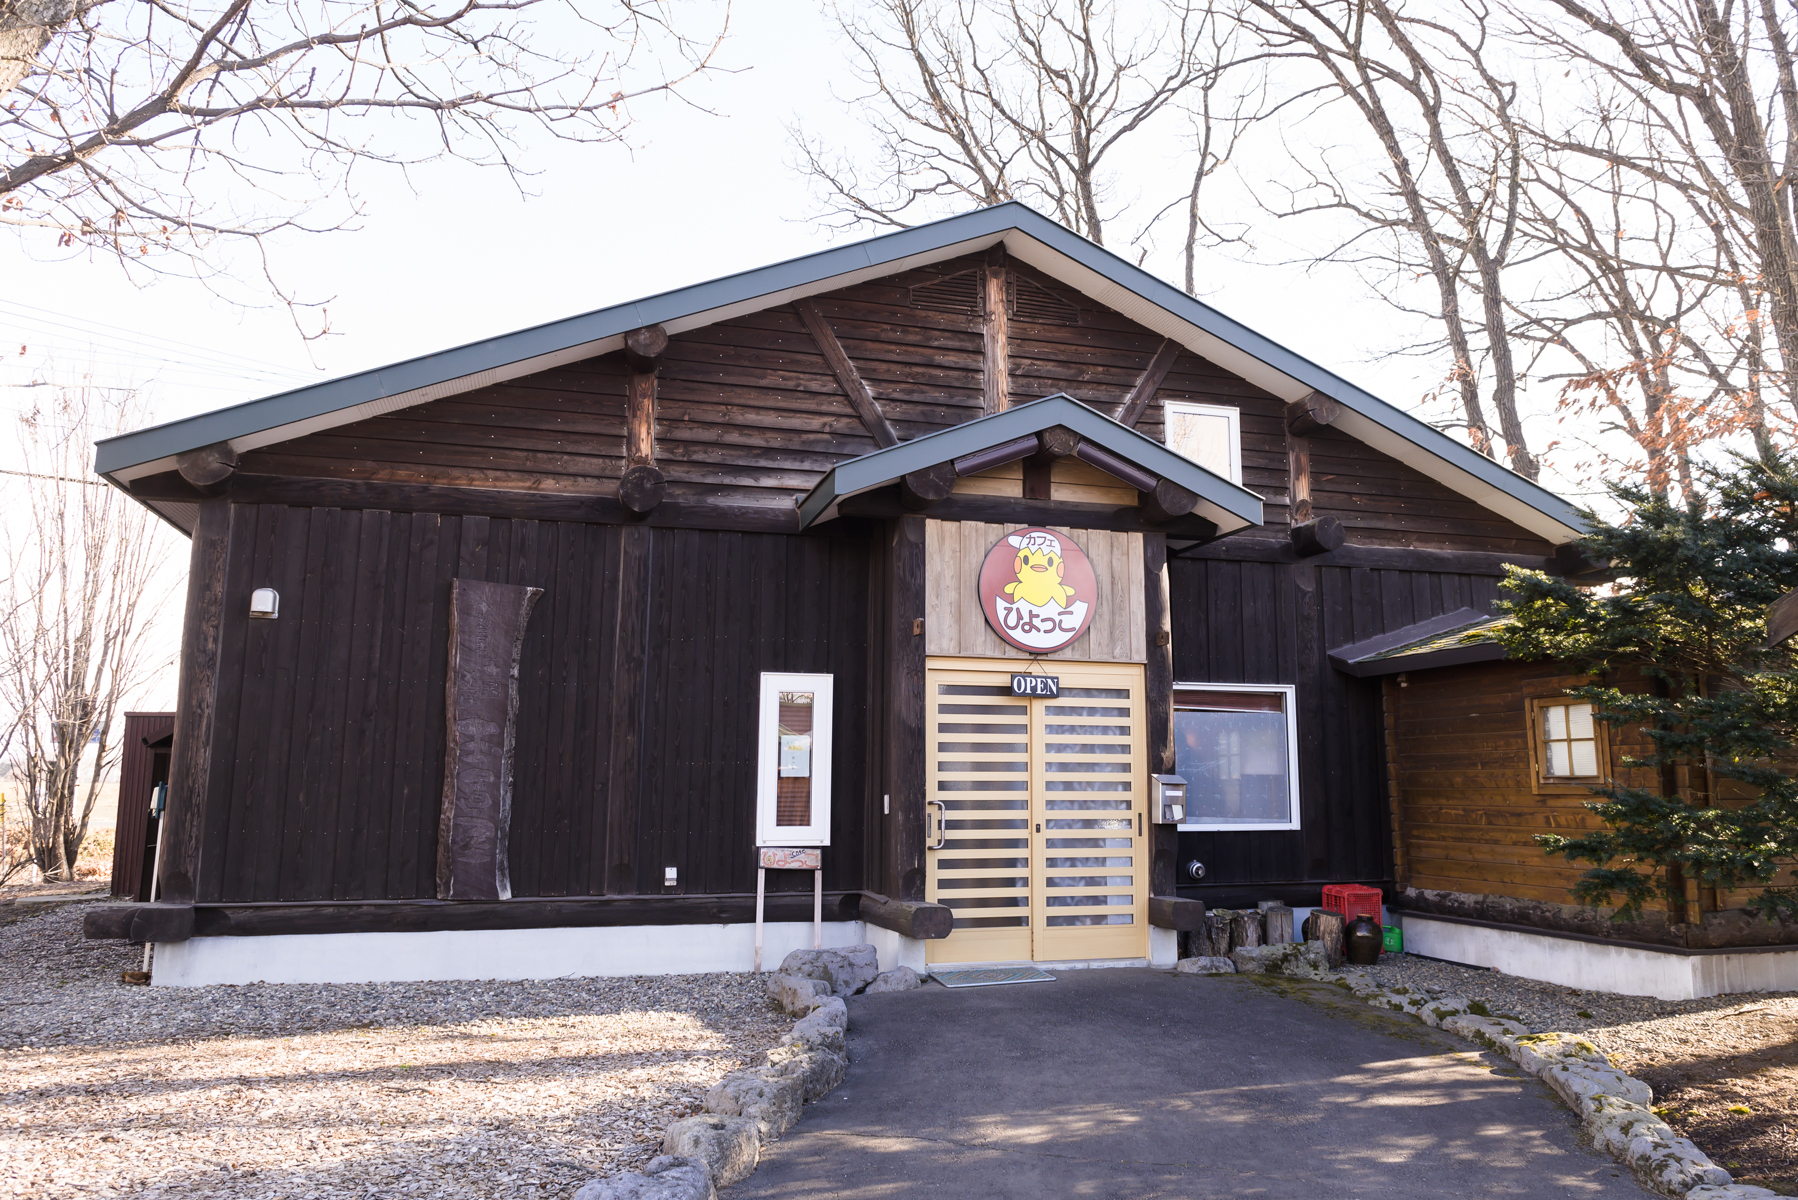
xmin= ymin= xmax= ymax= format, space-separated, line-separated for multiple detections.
xmin=798 ymin=392 xmax=1260 ymax=536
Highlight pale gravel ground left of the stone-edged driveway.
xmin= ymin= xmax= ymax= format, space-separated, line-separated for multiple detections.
xmin=0 ymin=903 xmax=791 ymax=1200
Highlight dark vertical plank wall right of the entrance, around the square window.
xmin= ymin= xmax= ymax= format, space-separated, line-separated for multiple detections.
xmin=1169 ymin=558 xmax=1500 ymax=896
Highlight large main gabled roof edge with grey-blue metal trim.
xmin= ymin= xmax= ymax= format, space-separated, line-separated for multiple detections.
xmin=93 ymin=201 xmax=1584 ymax=543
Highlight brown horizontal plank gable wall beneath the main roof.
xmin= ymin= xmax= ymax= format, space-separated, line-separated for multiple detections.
xmin=241 ymin=257 xmax=1552 ymax=554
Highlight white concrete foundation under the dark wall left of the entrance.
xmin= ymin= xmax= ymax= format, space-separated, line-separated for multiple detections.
xmin=151 ymin=921 xmax=891 ymax=988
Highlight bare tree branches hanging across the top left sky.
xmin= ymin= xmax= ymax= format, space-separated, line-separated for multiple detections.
xmin=0 ymin=0 xmax=728 ymax=329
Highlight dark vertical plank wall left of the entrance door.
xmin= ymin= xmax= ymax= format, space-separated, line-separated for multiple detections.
xmin=200 ymin=506 xmax=868 ymax=901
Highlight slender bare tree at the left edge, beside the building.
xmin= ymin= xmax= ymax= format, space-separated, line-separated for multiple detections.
xmin=0 ymin=387 xmax=180 ymax=880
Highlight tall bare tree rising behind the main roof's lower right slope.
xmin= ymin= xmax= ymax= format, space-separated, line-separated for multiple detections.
xmin=1244 ymin=0 xmax=1541 ymax=479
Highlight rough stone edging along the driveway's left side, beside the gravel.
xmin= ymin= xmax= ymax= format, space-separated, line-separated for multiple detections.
xmin=574 ymin=946 xmax=921 ymax=1200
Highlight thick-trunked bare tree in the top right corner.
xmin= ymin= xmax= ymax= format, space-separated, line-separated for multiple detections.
xmin=1512 ymin=0 xmax=1798 ymax=424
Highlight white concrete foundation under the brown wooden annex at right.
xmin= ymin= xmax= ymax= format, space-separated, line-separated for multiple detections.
xmin=1401 ymin=912 xmax=1798 ymax=1000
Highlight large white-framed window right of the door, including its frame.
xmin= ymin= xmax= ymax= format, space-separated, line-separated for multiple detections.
xmin=1174 ymin=684 xmax=1298 ymax=831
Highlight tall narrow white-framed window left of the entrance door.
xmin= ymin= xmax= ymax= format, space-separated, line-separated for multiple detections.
xmin=755 ymin=671 xmax=832 ymax=846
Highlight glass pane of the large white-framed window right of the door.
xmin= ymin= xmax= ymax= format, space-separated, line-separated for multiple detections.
xmin=1174 ymin=712 xmax=1293 ymax=824
